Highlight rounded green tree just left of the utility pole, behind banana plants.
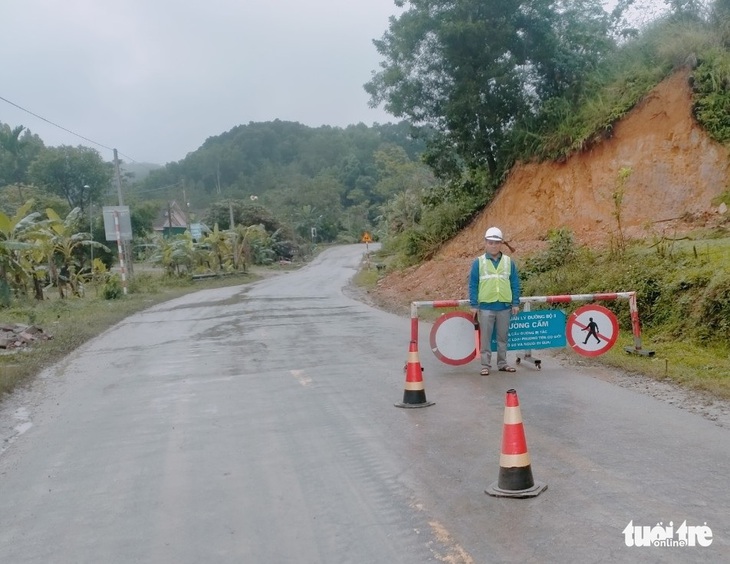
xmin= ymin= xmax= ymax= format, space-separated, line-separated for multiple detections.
xmin=29 ymin=145 xmax=113 ymax=209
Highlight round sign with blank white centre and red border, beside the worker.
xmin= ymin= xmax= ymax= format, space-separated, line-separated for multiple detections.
xmin=430 ymin=311 xmax=477 ymax=366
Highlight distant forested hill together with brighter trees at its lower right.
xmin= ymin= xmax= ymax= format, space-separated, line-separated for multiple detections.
xmin=130 ymin=120 xmax=435 ymax=241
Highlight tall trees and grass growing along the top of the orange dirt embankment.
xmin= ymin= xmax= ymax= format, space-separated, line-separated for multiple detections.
xmin=366 ymin=0 xmax=730 ymax=264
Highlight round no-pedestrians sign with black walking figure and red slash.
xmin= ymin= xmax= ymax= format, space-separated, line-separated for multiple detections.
xmin=565 ymin=304 xmax=618 ymax=356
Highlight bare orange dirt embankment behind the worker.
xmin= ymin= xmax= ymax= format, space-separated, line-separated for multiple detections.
xmin=374 ymin=71 xmax=730 ymax=304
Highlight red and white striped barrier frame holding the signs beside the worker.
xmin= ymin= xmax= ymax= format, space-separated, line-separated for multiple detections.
xmin=411 ymin=292 xmax=654 ymax=356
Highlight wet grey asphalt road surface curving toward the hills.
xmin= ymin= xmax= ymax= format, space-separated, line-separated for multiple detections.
xmin=0 ymin=245 xmax=730 ymax=564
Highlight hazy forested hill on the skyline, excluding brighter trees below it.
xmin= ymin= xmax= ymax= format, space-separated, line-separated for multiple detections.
xmin=139 ymin=120 xmax=425 ymax=207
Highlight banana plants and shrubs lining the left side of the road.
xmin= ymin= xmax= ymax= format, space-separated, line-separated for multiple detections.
xmin=0 ymin=201 xmax=296 ymax=307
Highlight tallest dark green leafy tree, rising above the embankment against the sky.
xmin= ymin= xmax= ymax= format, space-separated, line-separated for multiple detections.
xmin=365 ymin=0 xmax=612 ymax=188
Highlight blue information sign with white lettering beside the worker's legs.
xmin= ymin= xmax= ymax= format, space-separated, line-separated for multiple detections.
xmin=492 ymin=310 xmax=565 ymax=351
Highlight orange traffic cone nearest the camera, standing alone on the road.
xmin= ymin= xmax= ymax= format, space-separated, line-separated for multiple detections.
xmin=486 ymin=390 xmax=547 ymax=497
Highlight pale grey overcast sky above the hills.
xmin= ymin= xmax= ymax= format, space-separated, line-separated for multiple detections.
xmin=0 ymin=0 xmax=399 ymax=164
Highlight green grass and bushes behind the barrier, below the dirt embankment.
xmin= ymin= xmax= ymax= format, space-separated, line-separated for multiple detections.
xmin=520 ymin=229 xmax=730 ymax=399
